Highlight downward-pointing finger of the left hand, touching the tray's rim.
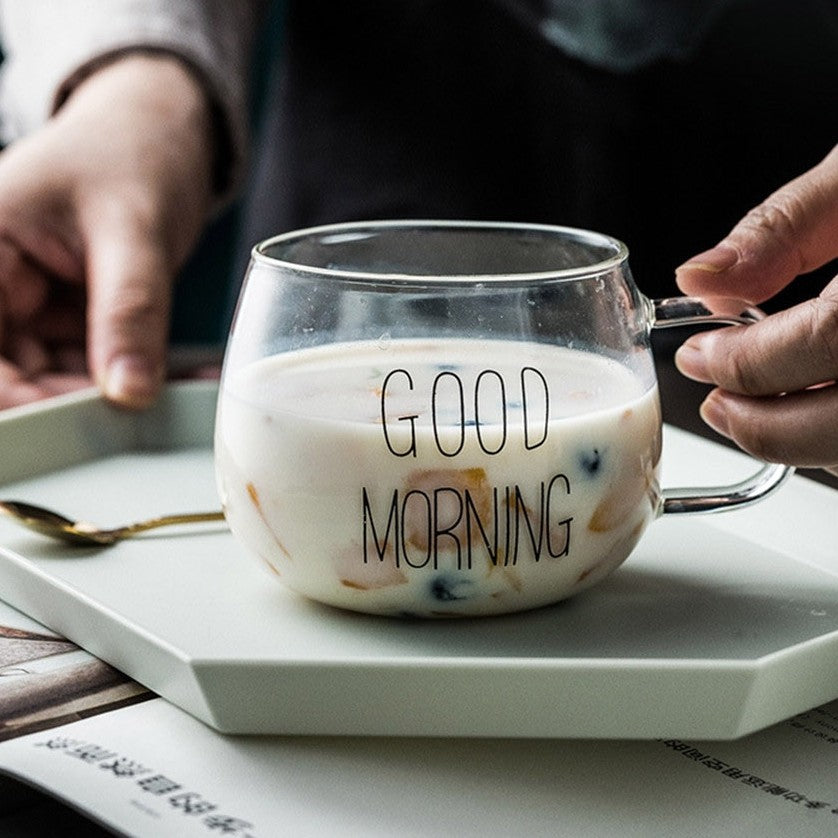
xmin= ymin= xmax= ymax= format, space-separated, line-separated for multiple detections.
xmin=87 ymin=221 xmax=173 ymax=408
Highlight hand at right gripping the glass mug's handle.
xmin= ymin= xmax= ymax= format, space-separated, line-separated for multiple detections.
xmin=675 ymin=146 xmax=838 ymax=474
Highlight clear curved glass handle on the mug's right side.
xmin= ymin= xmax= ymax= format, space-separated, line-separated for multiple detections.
xmin=648 ymin=297 xmax=794 ymax=514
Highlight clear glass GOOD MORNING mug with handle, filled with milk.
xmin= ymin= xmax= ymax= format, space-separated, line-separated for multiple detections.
xmin=215 ymin=221 xmax=789 ymax=617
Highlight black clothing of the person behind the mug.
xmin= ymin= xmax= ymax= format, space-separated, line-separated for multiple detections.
xmin=236 ymin=0 xmax=838 ymax=305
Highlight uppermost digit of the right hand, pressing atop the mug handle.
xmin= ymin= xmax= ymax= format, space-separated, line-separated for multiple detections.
xmin=675 ymin=146 xmax=838 ymax=303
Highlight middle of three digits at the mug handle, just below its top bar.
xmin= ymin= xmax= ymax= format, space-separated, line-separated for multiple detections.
xmin=675 ymin=279 xmax=838 ymax=396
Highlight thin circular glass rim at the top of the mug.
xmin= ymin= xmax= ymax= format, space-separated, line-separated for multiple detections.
xmin=251 ymin=218 xmax=629 ymax=285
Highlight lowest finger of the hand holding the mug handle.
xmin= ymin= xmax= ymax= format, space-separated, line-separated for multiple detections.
xmin=701 ymin=384 xmax=838 ymax=470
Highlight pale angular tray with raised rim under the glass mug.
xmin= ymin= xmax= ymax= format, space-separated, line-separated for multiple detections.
xmin=0 ymin=383 xmax=838 ymax=739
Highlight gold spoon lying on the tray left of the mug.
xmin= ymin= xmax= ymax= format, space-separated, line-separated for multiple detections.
xmin=0 ymin=500 xmax=224 ymax=547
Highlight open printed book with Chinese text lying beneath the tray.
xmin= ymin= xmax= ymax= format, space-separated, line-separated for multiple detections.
xmin=0 ymin=603 xmax=838 ymax=838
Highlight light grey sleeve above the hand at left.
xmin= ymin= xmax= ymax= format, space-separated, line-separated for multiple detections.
xmin=0 ymin=0 xmax=265 ymax=198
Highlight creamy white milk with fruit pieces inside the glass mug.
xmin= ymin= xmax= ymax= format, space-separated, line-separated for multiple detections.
xmin=216 ymin=339 xmax=661 ymax=616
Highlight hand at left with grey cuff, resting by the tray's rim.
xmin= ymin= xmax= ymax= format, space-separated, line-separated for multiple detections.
xmin=0 ymin=54 xmax=214 ymax=408
